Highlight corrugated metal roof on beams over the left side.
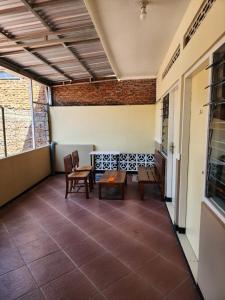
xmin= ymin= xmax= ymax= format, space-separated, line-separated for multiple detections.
xmin=0 ymin=0 xmax=114 ymax=85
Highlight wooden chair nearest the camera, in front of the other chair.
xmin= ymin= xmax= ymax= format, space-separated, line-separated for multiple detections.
xmin=64 ymin=154 xmax=90 ymax=199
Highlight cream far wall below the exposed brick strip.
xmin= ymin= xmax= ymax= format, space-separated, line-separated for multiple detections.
xmin=50 ymin=105 xmax=155 ymax=153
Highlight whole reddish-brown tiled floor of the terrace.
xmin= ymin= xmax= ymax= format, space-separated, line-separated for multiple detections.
xmin=0 ymin=175 xmax=200 ymax=300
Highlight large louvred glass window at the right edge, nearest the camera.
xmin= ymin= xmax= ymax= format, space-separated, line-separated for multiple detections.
xmin=206 ymin=44 xmax=225 ymax=213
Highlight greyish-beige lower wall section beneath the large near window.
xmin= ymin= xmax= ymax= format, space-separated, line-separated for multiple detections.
xmin=198 ymin=204 xmax=225 ymax=300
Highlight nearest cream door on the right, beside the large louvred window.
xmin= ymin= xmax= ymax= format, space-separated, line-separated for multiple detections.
xmin=186 ymin=70 xmax=208 ymax=258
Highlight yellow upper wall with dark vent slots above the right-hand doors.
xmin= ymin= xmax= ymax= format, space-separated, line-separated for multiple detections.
xmin=155 ymin=0 xmax=225 ymax=140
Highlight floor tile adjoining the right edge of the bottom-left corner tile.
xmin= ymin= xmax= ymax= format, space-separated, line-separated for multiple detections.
xmin=29 ymin=251 xmax=74 ymax=286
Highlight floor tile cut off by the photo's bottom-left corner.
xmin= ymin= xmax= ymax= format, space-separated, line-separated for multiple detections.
xmin=0 ymin=267 xmax=36 ymax=300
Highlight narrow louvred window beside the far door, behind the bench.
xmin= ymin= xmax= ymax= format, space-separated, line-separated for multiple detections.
xmin=162 ymin=94 xmax=169 ymax=155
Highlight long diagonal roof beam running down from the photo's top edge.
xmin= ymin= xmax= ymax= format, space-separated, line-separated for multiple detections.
xmin=21 ymin=0 xmax=95 ymax=79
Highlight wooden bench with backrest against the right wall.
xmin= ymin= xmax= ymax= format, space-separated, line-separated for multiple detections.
xmin=138 ymin=150 xmax=165 ymax=201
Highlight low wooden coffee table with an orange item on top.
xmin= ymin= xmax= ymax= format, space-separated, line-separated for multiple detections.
xmin=98 ymin=170 xmax=127 ymax=200
